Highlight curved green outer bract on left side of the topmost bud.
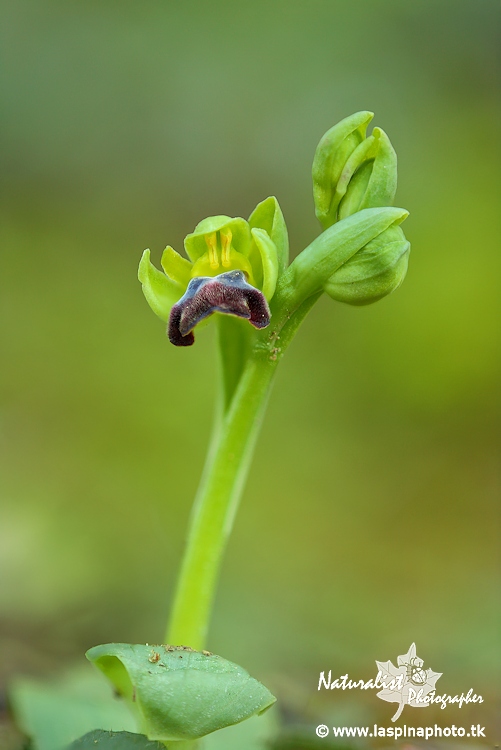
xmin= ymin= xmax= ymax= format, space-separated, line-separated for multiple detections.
xmin=312 ymin=111 xmax=374 ymax=229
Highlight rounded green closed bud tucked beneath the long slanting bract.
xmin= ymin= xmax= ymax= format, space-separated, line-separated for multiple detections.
xmin=324 ymin=226 xmax=410 ymax=305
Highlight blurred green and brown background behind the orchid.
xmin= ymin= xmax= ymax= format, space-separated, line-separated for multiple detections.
xmin=0 ymin=0 xmax=501 ymax=748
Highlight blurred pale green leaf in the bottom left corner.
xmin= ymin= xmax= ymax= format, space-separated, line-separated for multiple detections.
xmin=9 ymin=665 xmax=138 ymax=750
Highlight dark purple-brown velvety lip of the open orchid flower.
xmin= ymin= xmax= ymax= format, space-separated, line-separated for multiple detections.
xmin=167 ymin=271 xmax=270 ymax=346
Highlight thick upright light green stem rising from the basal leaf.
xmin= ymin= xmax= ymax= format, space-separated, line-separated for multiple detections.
xmin=166 ymin=294 xmax=320 ymax=650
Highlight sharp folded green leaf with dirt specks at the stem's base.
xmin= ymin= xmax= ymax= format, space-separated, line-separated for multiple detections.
xmin=86 ymin=643 xmax=276 ymax=742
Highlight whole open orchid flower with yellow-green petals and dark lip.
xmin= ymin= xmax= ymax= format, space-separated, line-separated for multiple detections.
xmin=138 ymin=197 xmax=288 ymax=346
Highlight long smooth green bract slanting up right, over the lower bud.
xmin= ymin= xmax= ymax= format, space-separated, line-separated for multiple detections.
xmin=282 ymin=207 xmax=409 ymax=306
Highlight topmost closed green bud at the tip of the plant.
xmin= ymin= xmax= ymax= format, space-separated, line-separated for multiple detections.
xmin=313 ymin=113 xmax=397 ymax=229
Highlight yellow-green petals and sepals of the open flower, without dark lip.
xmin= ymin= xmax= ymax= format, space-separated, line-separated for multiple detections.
xmin=138 ymin=197 xmax=288 ymax=321
